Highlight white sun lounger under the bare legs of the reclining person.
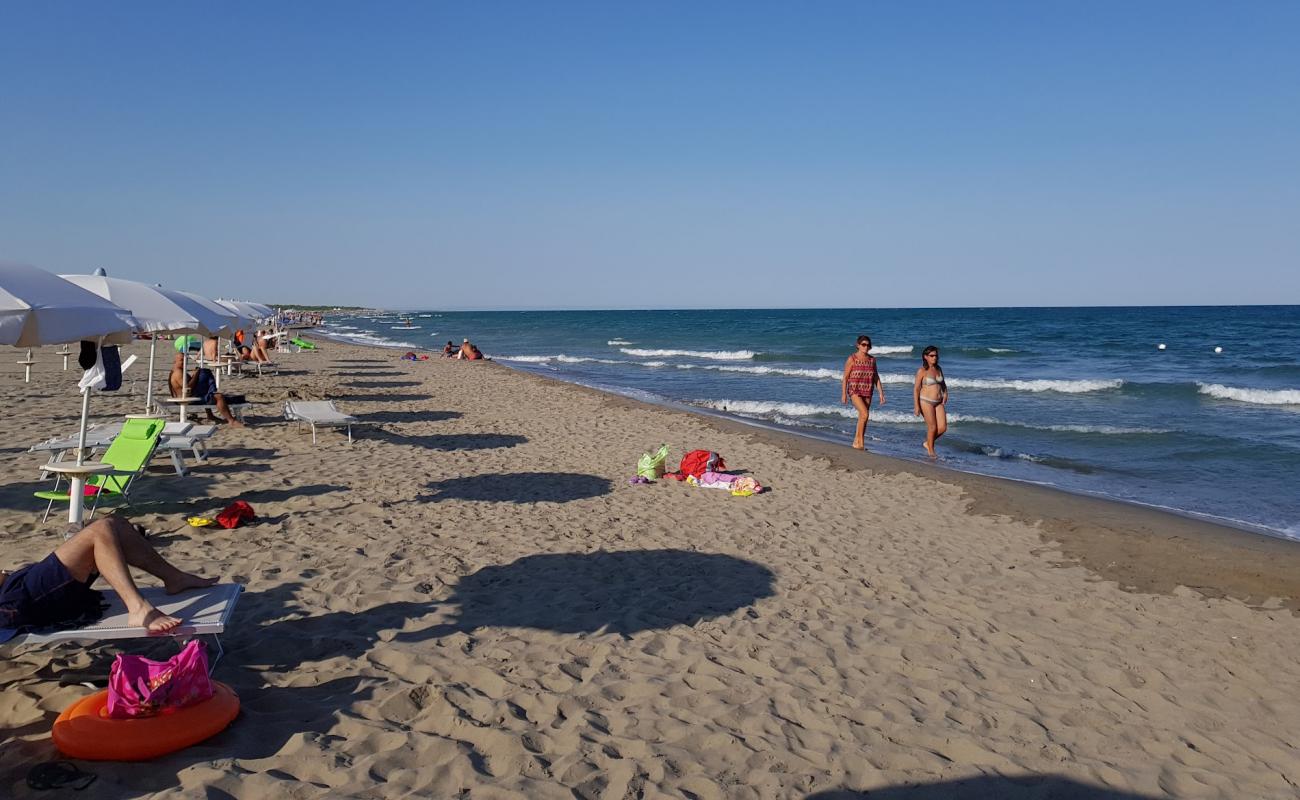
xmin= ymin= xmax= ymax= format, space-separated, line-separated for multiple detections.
xmin=3 ymin=583 xmax=243 ymax=669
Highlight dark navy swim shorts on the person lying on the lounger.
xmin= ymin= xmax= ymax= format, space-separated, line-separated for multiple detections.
xmin=0 ymin=553 xmax=104 ymax=641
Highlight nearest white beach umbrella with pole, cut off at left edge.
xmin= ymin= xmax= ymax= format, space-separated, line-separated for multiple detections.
xmin=0 ymin=263 xmax=137 ymax=523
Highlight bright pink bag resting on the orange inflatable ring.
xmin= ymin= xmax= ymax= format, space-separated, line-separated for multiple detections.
xmin=108 ymin=639 xmax=212 ymax=719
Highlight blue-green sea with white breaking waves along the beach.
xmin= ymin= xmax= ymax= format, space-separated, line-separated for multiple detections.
xmin=320 ymin=306 xmax=1300 ymax=540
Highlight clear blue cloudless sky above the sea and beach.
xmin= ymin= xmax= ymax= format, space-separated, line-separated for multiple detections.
xmin=0 ymin=0 xmax=1300 ymax=308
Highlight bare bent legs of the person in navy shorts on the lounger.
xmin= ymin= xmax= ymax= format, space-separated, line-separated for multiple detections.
xmin=55 ymin=516 xmax=217 ymax=633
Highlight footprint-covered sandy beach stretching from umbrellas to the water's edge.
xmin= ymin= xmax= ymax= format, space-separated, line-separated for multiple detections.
xmin=0 ymin=343 xmax=1300 ymax=800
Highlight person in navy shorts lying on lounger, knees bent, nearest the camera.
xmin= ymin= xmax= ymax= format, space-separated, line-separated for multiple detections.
xmin=0 ymin=516 xmax=217 ymax=641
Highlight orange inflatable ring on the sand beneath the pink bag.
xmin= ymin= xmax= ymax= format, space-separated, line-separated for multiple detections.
xmin=53 ymin=680 xmax=239 ymax=761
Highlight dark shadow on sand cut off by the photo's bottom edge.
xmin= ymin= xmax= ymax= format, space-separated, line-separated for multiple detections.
xmin=805 ymin=775 xmax=1154 ymax=800
